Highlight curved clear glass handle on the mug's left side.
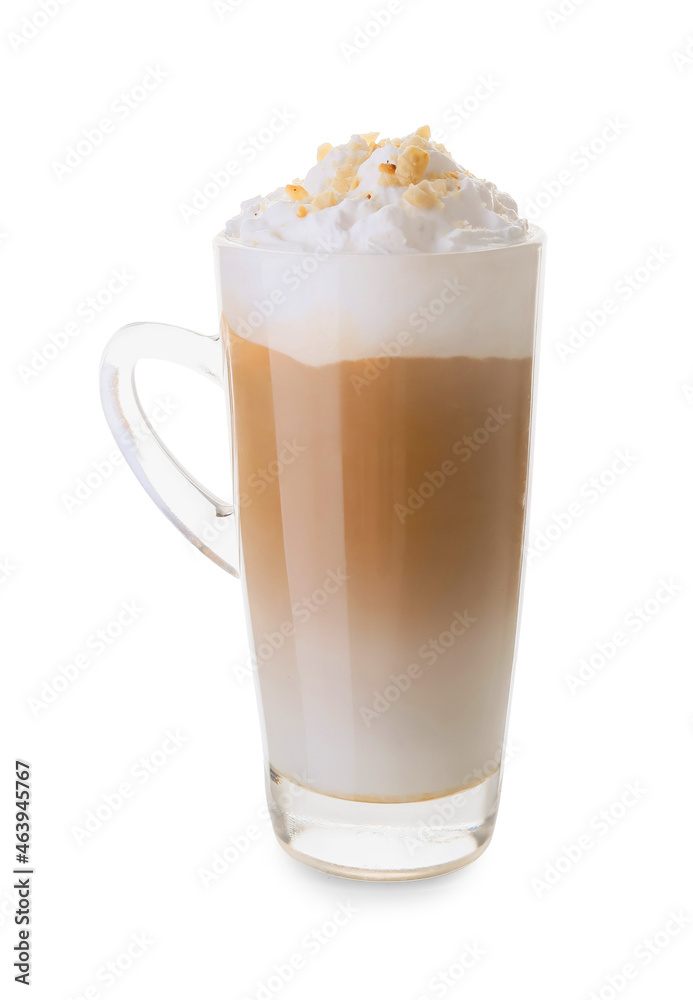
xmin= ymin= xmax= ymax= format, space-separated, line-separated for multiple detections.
xmin=101 ymin=323 xmax=239 ymax=577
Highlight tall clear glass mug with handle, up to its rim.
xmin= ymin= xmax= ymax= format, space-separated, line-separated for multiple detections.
xmin=101 ymin=227 xmax=545 ymax=881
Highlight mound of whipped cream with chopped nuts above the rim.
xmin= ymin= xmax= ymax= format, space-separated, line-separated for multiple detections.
xmin=226 ymin=126 xmax=529 ymax=254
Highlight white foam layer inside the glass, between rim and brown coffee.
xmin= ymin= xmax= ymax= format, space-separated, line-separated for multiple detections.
xmin=215 ymin=231 xmax=543 ymax=365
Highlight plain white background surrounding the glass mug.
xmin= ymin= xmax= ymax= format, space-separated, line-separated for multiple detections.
xmin=0 ymin=0 xmax=693 ymax=1000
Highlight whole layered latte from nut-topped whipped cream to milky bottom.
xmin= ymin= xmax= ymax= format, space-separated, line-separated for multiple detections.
xmin=216 ymin=128 xmax=542 ymax=864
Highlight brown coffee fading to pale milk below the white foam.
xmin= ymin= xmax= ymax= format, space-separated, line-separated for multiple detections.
xmin=224 ymin=327 xmax=531 ymax=798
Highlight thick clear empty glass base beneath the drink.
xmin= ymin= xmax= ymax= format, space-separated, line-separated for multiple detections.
xmin=267 ymin=769 xmax=500 ymax=882
